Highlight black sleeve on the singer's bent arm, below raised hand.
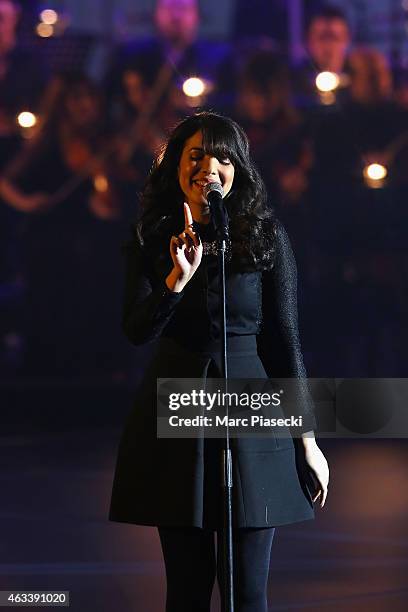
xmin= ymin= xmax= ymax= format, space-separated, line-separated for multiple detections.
xmin=122 ymin=240 xmax=184 ymax=345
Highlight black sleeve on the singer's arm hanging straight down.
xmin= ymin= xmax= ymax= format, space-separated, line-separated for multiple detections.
xmin=258 ymin=221 xmax=317 ymax=434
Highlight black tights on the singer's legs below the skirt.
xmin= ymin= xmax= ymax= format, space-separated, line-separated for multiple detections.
xmin=158 ymin=527 xmax=275 ymax=612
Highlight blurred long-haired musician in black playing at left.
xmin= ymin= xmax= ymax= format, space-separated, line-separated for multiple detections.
xmin=0 ymin=73 xmax=121 ymax=377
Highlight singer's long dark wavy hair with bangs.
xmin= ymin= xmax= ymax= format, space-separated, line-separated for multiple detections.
xmin=133 ymin=111 xmax=276 ymax=271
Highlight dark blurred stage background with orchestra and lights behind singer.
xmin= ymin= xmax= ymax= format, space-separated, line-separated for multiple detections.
xmin=0 ymin=0 xmax=408 ymax=612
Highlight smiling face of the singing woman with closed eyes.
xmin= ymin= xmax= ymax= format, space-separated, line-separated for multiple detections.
xmin=178 ymin=131 xmax=235 ymax=210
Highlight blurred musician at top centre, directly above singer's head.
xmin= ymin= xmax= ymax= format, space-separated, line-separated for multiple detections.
xmin=106 ymin=0 xmax=229 ymax=135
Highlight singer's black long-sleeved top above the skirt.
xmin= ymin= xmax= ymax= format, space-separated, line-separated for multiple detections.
xmin=118 ymin=221 xmax=316 ymax=404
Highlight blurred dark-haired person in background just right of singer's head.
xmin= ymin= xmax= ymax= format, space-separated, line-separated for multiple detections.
xmin=234 ymin=50 xmax=312 ymax=212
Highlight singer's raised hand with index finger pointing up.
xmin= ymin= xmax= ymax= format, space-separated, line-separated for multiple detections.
xmin=166 ymin=202 xmax=203 ymax=292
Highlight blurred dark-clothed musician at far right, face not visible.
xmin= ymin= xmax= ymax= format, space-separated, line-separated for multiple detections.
xmin=308 ymin=48 xmax=402 ymax=219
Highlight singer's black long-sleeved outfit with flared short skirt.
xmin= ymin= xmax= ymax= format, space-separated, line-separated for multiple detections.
xmin=109 ymin=222 xmax=316 ymax=527
